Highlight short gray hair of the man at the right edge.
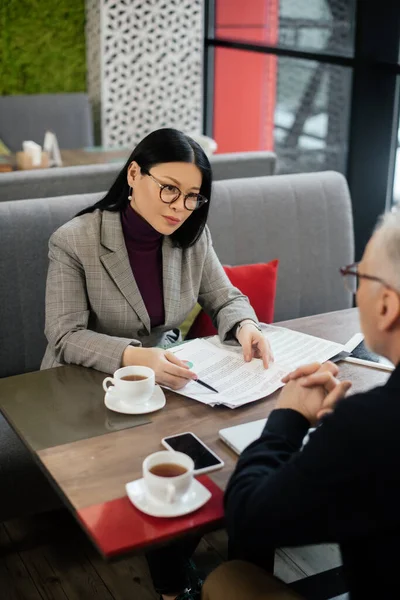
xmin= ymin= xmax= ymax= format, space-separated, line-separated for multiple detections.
xmin=375 ymin=209 xmax=400 ymax=290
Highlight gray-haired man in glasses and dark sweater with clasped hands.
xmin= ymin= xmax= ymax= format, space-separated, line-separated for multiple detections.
xmin=203 ymin=213 xmax=400 ymax=600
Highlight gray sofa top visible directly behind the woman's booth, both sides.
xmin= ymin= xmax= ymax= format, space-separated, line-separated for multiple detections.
xmin=0 ymin=151 xmax=276 ymax=202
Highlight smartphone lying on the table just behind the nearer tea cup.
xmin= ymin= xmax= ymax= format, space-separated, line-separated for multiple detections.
xmin=161 ymin=431 xmax=224 ymax=475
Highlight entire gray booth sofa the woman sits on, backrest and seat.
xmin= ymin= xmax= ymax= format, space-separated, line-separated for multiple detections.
xmin=0 ymin=172 xmax=354 ymax=521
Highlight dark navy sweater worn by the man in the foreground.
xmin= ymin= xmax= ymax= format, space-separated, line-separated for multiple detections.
xmin=225 ymin=366 xmax=400 ymax=600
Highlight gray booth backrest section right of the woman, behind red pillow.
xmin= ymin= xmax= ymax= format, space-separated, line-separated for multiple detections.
xmin=209 ymin=171 xmax=354 ymax=321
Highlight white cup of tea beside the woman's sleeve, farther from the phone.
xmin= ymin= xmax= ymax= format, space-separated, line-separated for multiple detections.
xmin=103 ymin=366 xmax=155 ymax=405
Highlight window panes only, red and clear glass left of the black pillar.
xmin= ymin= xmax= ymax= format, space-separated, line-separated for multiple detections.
xmin=213 ymin=0 xmax=354 ymax=173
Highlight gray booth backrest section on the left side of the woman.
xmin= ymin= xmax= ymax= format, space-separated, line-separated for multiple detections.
xmin=0 ymin=194 xmax=102 ymax=377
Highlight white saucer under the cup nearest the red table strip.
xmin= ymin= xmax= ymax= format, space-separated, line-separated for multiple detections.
xmin=125 ymin=479 xmax=211 ymax=517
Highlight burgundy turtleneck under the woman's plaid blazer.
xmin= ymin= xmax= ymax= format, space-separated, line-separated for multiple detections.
xmin=121 ymin=204 xmax=165 ymax=328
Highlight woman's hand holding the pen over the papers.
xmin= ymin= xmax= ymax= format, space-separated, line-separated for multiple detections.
xmin=121 ymin=346 xmax=197 ymax=390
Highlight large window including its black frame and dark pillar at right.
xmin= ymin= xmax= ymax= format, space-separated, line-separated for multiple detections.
xmin=204 ymin=0 xmax=400 ymax=259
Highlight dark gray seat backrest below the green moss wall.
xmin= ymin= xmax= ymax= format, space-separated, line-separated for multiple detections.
xmin=0 ymin=93 xmax=93 ymax=152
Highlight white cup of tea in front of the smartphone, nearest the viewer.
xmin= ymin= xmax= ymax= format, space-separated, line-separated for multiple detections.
xmin=143 ymin=450 xmax=194 ymax=504
